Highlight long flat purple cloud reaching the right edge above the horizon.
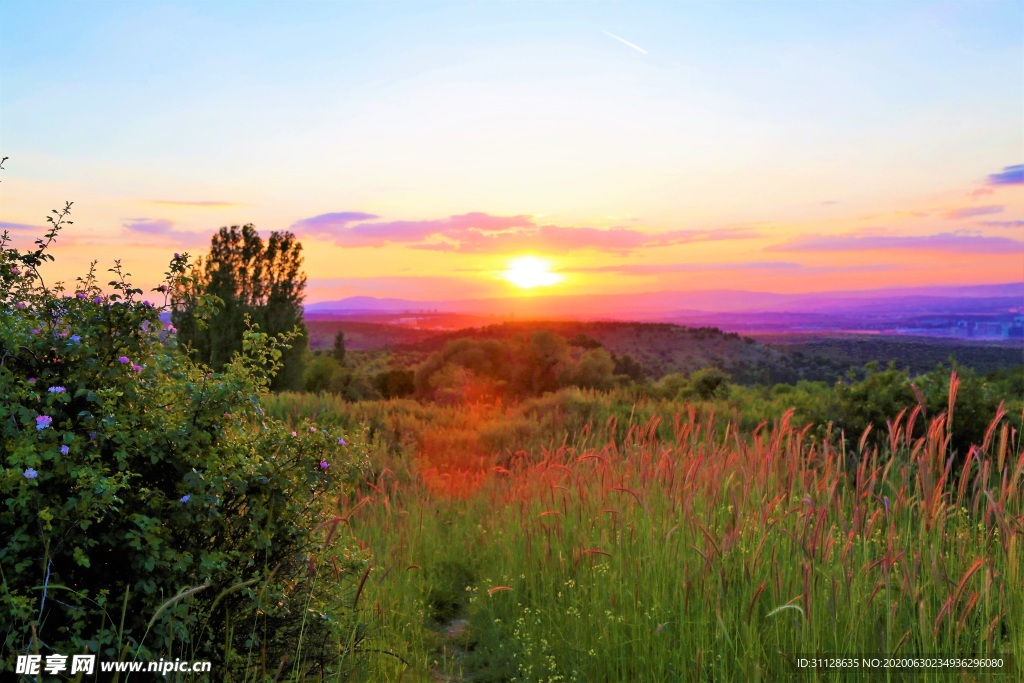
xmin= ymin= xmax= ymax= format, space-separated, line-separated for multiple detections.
xmin=765 ymin=230 xmax=1024 ymax=254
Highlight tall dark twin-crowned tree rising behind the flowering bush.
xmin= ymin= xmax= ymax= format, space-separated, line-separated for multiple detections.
xmin=171 ymin=223 xmax=307 ymax=390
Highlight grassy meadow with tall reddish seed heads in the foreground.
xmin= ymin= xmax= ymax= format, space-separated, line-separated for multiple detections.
xmin=264 ymin=374 xmax=1024 ymax=682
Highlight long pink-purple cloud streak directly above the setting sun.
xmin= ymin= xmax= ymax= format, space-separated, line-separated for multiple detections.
xmin=292 ymin=212 xmax=760 ymax=254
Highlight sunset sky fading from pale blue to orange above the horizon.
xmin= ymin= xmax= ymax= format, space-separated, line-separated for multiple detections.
xmin=0 ymin=0 xmax=1024 ymax=302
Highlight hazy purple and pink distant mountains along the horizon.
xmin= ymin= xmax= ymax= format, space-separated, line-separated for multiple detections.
xmin=305 ymin=282 xmax=1024 ymax=339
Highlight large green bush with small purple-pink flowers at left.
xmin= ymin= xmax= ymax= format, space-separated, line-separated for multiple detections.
xmin=0 ymin=204 xmax=366 ymax=671
